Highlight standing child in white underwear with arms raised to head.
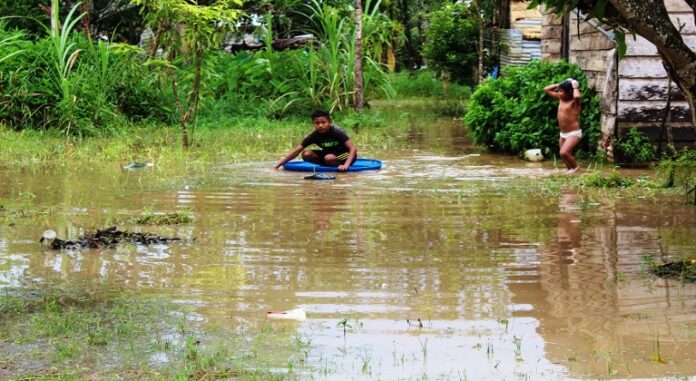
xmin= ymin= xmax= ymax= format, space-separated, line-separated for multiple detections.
xmin=544 ymin=78 xmax=582 ymax=174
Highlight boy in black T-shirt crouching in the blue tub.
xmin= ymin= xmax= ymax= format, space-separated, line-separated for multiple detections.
xmin=273 ymin=111 xmax=358 ymax=171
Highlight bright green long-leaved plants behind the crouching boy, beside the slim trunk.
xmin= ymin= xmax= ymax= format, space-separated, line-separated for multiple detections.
xmin=210 ymin=2 xmax=393 ymax=118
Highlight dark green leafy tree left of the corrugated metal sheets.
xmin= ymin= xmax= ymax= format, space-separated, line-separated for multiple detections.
xmin=423 ymin=2 xmax=479 ymax=84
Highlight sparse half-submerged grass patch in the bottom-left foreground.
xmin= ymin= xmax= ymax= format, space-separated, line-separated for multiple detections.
xmin=0 ymin=284 xmax=300 ymax=380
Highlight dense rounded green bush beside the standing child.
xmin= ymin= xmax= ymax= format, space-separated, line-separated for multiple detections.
xmin=465 ymin=61 xmax=600 ymax=156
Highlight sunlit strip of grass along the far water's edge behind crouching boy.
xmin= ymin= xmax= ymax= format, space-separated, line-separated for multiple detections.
xmin=0 ymin=111 xmax=399 ymax=171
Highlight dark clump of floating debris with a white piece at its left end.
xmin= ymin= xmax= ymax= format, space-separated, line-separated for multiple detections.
xmin=39 ymin=226 xmax=181 ymax=250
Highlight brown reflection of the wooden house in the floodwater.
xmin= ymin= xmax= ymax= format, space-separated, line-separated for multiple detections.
xmin=510 ymin=192 xmax=696 ymax=376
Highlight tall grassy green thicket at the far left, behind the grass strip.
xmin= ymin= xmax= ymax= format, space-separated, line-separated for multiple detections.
xmin=0 ymin=4 xmax=171 ymax=136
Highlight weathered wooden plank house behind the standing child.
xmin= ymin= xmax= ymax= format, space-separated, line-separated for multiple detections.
xmin=541 ymin=0 xmax=696 ymax=155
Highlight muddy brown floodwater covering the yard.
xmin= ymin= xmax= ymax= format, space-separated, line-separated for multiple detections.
xmin=0 ymin=104 xmax=696 ymax=380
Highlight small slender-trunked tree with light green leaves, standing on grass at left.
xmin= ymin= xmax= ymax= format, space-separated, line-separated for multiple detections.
xmin=132 ymin=0 xmax=242 ymax=148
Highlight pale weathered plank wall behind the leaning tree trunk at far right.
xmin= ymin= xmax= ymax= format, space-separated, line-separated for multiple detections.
xmin=618 ymin=0 xmax=696 ymax=146
